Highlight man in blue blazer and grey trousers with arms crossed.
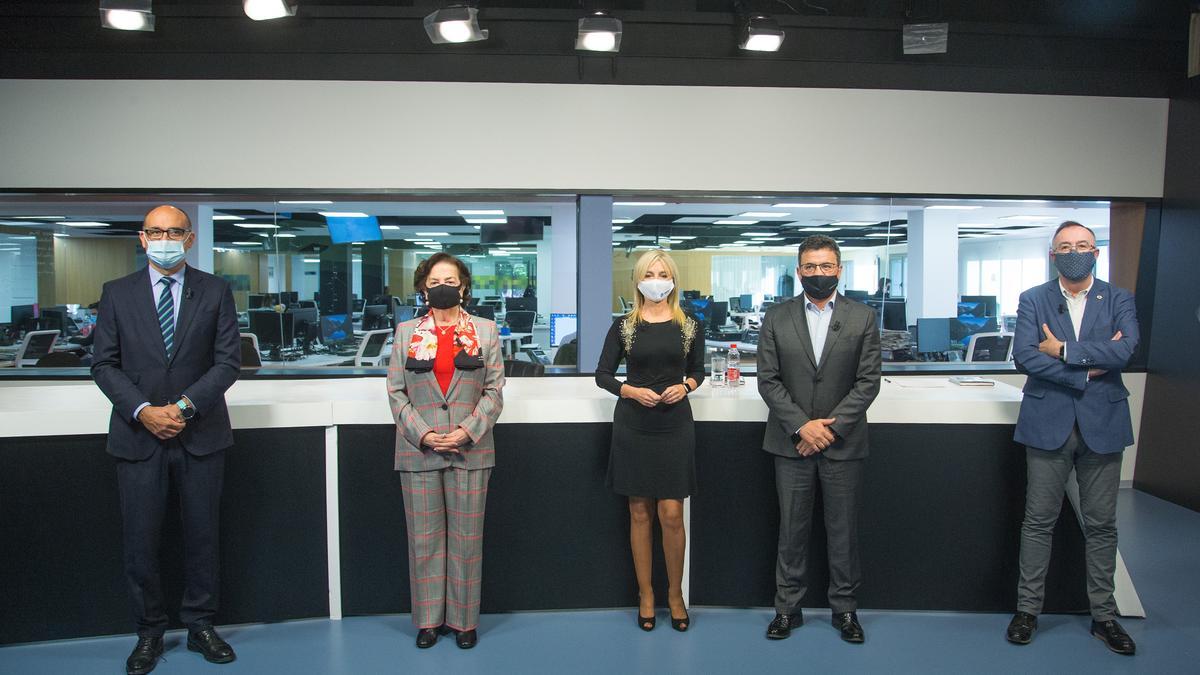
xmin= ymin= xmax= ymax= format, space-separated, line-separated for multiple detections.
xmin=1007 ymin=221 xmax=1138 ymax=655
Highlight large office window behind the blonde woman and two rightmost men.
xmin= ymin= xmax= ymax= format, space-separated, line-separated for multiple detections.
xmin=612 ymin=196 xmax=1142 ymax=369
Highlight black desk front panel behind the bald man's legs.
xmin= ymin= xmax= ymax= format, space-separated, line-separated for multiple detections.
xmin=0 ymin=429 xmax=329 ymax=644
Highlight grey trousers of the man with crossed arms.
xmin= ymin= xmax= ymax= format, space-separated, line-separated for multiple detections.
xmin=1016 ymin=426 xmax=1121 ymax=621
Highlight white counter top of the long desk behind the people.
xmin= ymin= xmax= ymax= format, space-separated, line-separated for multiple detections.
xmin=0 ymin=376 xmax=1021 ymax=436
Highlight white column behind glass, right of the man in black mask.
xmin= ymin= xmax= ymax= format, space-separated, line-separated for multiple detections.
xmin=902 ymin=210 xmax=961 ymax=325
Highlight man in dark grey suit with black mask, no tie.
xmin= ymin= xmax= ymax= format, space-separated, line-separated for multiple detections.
xmin=758 ymin=235 xmax=882 ymax=644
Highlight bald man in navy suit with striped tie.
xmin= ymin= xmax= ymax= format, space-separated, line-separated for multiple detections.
xmin=91 ymin=205 xmax=241 ymax=675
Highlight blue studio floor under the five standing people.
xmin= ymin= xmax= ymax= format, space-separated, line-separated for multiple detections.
xmin=0 ymin=490 xmax=1200 ymax=675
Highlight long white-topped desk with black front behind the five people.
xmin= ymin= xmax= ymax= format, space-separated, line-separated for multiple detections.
xmin=0 ymin=375 xmax=1104 ymax=644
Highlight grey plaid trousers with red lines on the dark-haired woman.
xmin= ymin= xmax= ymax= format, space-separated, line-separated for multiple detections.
xmin=400 ymin=467 xmax=492 ymax=631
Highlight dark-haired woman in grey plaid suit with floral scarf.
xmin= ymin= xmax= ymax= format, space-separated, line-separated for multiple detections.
xmin=388 ymin=253 xmax=504 ymax=649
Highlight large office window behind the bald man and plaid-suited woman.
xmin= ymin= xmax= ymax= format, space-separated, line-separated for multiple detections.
xmin=0 ymin=195 xmax=576 ymax=369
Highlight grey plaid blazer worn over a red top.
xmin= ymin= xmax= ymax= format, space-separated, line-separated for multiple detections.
xmin=388 ymin=316 xmax=504 ymax=471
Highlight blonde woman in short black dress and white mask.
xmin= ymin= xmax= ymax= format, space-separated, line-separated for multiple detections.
xmin=596 ymin=250 xmax=704 ymax=632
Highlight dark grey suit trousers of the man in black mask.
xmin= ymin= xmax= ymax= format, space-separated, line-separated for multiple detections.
xmin=775 ymin=454 xmax=866 ymax=614
